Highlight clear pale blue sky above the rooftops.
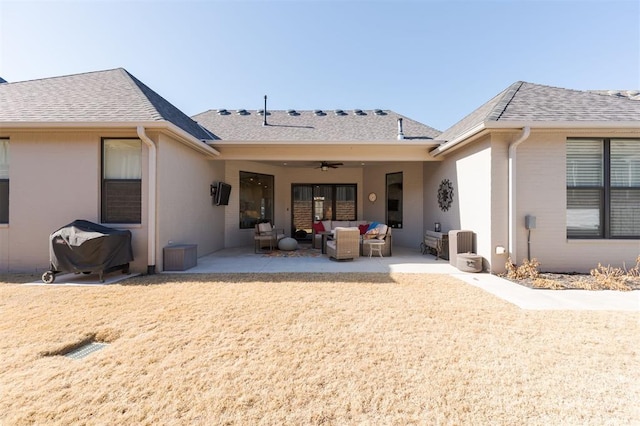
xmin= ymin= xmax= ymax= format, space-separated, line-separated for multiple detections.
xmin=0 ymin=0 xmax=640 ymax=130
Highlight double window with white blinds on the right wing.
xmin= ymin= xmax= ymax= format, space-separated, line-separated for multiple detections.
xmin=567 ymin=139 xmax=640 ymax=238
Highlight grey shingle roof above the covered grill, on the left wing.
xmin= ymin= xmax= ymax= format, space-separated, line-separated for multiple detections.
xmin=0 ymin=68 xmax=212 ymax=140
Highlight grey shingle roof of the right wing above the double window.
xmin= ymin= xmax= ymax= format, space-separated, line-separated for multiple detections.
xmin=438 ymin=81 xmax=640 ymax=141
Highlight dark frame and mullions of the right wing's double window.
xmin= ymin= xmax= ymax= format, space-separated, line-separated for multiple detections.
xmin=565 ymin=137 xmax=640 ymax=240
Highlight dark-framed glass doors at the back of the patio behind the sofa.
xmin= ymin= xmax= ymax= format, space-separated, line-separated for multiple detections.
xmin=291 ymin=183 xmax=358 ymax=240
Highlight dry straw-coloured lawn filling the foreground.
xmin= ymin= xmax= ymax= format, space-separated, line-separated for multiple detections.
xmin=0 ymin=274 xmax=640 ymax=425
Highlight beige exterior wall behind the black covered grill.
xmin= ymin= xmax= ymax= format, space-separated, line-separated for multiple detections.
xmin=0 ymin=131 xmax=147 ymax=272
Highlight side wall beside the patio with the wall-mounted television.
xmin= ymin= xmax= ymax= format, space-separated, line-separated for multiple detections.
xmin=151 ymin=134 xmax=225 ymax=271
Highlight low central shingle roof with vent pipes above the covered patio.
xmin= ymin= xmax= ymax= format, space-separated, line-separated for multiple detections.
xmin=192 ymin=110 xmax=440 ymax=142
